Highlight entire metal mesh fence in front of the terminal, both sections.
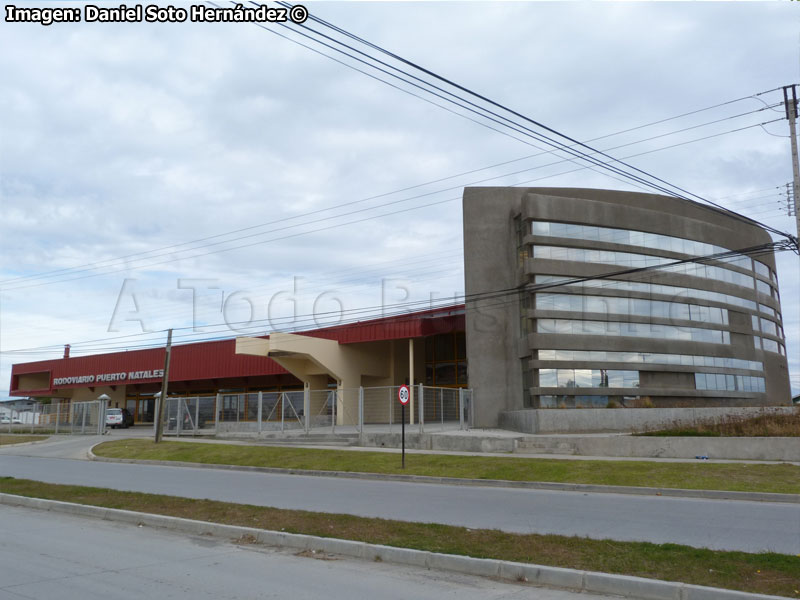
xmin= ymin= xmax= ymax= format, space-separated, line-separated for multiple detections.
xmin=0 ymin=385 xmax=472 ymax=437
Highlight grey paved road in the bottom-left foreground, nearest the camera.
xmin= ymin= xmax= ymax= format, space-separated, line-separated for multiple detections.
xmin=0 ymin=506 xmax=620 ymax=600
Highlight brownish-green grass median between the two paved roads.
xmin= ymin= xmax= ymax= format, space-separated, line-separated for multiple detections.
xmin=0 ymin=477 xmax=800 ymax=598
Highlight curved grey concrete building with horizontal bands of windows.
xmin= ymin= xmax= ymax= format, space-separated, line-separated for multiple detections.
xmin=464 ymin=187 xmax=790 ymax=423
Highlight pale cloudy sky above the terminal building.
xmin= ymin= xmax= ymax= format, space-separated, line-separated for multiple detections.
xmin=0 ymin=2 xmax=800 ymax=398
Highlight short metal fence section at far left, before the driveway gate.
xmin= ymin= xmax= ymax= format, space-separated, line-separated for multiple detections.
xmin=0 ymin=400 xmax=107 ymax=435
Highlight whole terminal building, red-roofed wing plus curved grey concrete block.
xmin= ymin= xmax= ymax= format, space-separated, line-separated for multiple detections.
xmin=10 ymin=188 xmax=791 ymax=427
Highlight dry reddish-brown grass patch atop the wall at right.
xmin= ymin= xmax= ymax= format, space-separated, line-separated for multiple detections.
xmin=640 ymin=408 xmax=800 ymax=437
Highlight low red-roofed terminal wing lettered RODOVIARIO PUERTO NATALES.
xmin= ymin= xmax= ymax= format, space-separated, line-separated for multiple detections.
xmin=10 ymin=305 xmax=468 ymax=423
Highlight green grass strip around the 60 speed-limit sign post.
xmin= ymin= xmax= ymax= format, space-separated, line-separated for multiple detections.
xmin=94 ymin=439 xmax=800 ymax=494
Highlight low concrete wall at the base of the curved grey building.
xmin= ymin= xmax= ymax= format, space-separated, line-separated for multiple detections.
xmin=500 ymin=406 xmax=800 ymax=434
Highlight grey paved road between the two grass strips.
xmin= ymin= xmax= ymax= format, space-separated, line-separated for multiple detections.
xmin=0 ymin=451 xmax=800 ymax=554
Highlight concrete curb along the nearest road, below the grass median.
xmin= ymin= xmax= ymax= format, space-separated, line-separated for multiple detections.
xmin=0 ymin=493 xmax=786 ymax=600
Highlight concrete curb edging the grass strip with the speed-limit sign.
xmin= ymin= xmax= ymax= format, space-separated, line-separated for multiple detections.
xmin=87 ymin=442 xmax=800 ymax=504
